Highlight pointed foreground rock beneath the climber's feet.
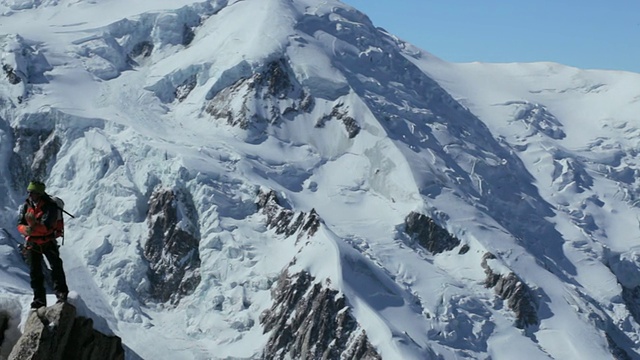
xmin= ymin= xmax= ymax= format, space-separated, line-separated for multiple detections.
xmin=9 ymin=303 xmax=124 ymax=360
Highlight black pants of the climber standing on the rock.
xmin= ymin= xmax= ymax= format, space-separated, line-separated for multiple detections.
xmin=27 ymin=240 xmax=69 ymax=304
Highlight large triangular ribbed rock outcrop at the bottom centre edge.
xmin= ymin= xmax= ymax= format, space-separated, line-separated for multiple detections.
xmin=260 ymin=271 xmax=381 ymax=359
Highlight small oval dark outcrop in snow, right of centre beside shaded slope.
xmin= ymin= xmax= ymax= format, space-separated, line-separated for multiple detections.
xmin=404 ymin=212 xmax=460 ymax=254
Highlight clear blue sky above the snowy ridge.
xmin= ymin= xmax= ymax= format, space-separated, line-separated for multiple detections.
xmin=343 ymin=0 xmax=640 ymax=73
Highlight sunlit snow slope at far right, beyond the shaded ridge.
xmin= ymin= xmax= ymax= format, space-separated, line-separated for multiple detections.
xmin=405 ymin=52 xmax=640 ymax=357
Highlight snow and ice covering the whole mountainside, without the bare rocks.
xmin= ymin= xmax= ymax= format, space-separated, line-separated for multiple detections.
xmin=0 ymin=0 xmax=640 ymax=359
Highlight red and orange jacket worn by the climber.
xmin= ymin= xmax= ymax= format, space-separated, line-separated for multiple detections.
xmin=18 ymin=195 xmax=57 ymax=244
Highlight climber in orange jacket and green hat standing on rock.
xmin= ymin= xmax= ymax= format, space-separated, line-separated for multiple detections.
xmin=18 ymin=181 xmax=69 ymax=309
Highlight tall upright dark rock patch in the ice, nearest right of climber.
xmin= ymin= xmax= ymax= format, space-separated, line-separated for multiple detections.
xmin=144 ymin=190 xmax=200 ymax=304
